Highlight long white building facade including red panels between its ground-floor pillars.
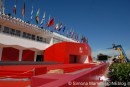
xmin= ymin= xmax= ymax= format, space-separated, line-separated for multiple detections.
xmin=0 ymin=14 xmax=78 ymax=61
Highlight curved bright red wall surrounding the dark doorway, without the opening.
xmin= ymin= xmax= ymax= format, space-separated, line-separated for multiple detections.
xmin=44 ymin=42 xmax=92 ymax=63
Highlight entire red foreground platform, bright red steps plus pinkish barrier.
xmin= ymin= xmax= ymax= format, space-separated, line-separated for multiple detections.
xmin=0 ymin=63 xmax=108 ymax=87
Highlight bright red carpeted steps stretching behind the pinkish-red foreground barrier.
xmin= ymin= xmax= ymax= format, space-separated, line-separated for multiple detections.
xmin=0 ymin=64 xmax=96 ymax=78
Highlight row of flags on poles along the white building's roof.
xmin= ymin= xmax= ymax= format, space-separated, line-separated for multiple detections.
xmin=13 ymin=2 xmax=88 ymax=43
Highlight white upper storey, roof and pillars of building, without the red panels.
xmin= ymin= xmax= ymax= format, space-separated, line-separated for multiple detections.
xmin=0 ymin=13 xmax=77 ymax=61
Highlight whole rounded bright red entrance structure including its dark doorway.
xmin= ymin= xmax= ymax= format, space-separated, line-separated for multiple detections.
xmin=44 ymin=42 xmax=92 ymax=64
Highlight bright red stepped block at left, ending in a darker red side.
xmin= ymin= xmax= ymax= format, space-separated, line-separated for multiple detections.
xmin=0 ymin=65 xmax=47 ymax=78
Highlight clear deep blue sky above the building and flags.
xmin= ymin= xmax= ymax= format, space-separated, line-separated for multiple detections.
xmin=5 ymin=0 xmax=130 ymax=56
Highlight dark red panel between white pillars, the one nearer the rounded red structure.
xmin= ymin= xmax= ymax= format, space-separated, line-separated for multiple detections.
xmin=22 ymin=50 xmax=35 ymax=61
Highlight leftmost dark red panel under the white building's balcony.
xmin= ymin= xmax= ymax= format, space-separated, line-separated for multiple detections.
xmin=1 ymin=47 xmax=19 ymax=61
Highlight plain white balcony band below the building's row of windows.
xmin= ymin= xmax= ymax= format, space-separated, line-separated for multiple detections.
xmin=0 ymin=33 xmax=49 ymax=50
